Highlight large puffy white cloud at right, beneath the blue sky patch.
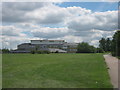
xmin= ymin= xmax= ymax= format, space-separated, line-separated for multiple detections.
xmin=68 ymin=11 xmax=118 ymax=31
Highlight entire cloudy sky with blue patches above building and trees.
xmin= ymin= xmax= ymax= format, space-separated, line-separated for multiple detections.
xmin=0 ymin=2 xmax=118 ymax=49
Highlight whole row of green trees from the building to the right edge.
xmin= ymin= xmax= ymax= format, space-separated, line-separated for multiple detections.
xmin=77 ymin=31 xmax=120 ymax=57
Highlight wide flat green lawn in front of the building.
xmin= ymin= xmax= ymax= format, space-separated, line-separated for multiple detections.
xmin=3 ymin=54 xmax=112 ymax=88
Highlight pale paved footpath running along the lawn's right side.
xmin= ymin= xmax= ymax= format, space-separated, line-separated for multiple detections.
xmin=104 ymin=54 xmax=120 ymax=88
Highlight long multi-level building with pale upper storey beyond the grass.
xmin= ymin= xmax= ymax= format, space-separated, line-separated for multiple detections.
xmin=12 ymin=40 xmax=78 ymax=53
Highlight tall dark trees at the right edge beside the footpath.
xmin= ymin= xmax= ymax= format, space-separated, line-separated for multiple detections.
xmin=99 ymin=31 xmax=120 ymax=56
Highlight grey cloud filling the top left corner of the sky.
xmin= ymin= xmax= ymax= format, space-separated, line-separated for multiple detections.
xmin=2 ymin=2 xmax=52 ymax=23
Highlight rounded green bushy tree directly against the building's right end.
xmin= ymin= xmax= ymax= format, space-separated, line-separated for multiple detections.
xmin=77 ymin=42 xmax=95 ymax=53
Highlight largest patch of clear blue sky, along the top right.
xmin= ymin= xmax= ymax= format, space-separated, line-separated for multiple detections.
xmin=57 ymin=2 xmax=118 ymax=12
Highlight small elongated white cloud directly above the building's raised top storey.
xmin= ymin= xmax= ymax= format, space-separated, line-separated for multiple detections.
xmin=31 ymin=27 xmax=69 ymax=39
